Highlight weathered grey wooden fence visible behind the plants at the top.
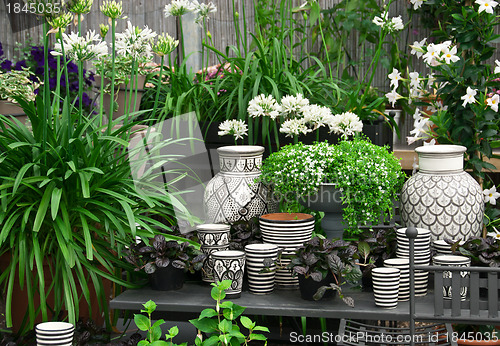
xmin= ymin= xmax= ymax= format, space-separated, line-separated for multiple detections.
xmin=0 ymin=0 xmax=426 ymax=89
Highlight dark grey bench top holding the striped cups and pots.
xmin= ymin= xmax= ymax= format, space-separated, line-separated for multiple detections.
xmin=110 ymin=282 xmax=434 ymax=321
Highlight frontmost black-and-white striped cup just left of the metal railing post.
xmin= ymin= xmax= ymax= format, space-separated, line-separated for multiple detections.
xmin=372 ymin=267 xmax=401 ymax=309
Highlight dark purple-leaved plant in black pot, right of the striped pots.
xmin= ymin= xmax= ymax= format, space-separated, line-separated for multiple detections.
xmin=287 ymin=237 xmax=361 ymax=306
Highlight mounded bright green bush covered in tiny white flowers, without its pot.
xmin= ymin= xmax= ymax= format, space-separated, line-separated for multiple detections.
xmin=261 ymin=137 xmax=405 ymax=234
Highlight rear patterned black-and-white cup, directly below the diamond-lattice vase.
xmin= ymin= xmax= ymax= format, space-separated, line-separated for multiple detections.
xmin=196 ymin=223 xmax=231 ymax=283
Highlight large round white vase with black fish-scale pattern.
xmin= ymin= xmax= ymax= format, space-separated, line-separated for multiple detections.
xmin=401 ymin=145 xmax=484 ymax=240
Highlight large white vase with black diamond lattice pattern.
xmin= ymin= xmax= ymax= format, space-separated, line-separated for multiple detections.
xmin=205 ymin=145 xmax=278 ymax=224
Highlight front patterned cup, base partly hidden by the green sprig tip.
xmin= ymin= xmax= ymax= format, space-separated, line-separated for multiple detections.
xmin=210 ymin=250 xmax=245 ymax=298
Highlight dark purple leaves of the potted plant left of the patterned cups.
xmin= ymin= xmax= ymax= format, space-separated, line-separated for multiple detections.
xmin=125 ymin=234 xmax=206 ymax=274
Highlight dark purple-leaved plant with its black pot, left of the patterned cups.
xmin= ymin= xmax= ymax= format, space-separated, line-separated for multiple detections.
xmin=125 ymin=234 xmax=206 ymax=291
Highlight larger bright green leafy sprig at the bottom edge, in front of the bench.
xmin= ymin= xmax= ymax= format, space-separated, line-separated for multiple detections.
xmin=189 ymin=280 xmax=269 ymax=346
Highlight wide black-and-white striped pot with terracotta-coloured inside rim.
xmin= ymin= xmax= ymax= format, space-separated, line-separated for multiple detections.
xmin=259 ymin=213 xmax=314 ymax=289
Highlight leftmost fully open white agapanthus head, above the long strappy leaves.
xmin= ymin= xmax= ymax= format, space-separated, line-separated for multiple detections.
xmin=51 ymin=30 xmax=108 ymax=61
